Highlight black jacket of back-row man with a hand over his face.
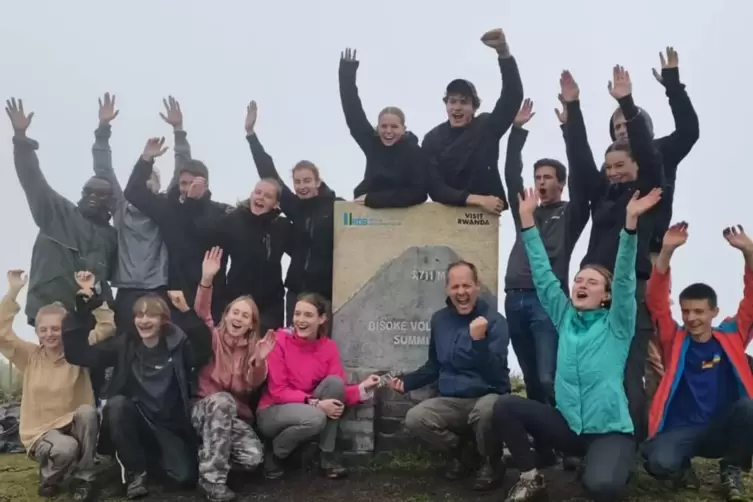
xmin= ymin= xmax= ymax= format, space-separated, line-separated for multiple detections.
xmin=123 ymin=158 xmax=228 ymax=314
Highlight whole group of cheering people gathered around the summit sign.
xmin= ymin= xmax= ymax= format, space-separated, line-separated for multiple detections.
xmin=0 ymin=26 xmax=753 ymax=502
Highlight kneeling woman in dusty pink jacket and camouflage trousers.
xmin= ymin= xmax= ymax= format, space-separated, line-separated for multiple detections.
xmin=191 ymin=247 xmax=274 ymax=502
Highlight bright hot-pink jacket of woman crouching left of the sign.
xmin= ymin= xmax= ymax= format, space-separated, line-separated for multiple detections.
xmin=258 ymin=328 xmax=362 ymax=410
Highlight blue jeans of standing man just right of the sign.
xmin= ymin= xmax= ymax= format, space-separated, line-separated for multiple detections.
xmin=505 ymin=290 xmax=559 ymax=405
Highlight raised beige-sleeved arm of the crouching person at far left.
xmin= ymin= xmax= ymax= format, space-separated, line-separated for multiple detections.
xmin=0 ymin=270 xmax=39 ymax=372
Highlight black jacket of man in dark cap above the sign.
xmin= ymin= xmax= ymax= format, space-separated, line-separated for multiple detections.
xmin=421 ymin=56 xmax=523 ymax=207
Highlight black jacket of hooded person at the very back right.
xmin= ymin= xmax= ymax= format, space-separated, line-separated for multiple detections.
xmin=609 ymin=68 xmax=700 ymax=253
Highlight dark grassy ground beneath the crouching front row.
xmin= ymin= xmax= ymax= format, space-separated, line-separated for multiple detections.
xmin=0 ymin=454 xmax=753 ymax=502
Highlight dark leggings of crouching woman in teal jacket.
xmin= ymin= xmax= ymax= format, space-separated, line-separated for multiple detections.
xmin=494 ymin=394 xmax=636 ymax=502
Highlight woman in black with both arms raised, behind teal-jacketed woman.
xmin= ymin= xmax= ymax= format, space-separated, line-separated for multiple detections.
xmin=560 ymin=66 xmax=664 ymax=441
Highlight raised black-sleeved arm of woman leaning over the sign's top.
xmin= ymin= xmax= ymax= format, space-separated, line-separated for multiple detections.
xmin=338 ymin=49 xmax=375 ymax=154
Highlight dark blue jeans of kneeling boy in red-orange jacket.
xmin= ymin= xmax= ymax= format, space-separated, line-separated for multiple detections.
xmin=641 ymin=398 xmax=753 ymax=479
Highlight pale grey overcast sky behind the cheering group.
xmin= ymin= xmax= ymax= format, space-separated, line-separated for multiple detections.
xmin=0 ymin=0 xmax=753 ymax=368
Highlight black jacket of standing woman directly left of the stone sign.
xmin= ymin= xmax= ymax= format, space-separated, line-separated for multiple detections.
xmin=246 ymin=134 xmax=342 ymax=299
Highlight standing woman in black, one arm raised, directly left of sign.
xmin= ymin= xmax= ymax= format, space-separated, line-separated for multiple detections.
xmin=246 ymin=101 xmax=343 ymax=326
